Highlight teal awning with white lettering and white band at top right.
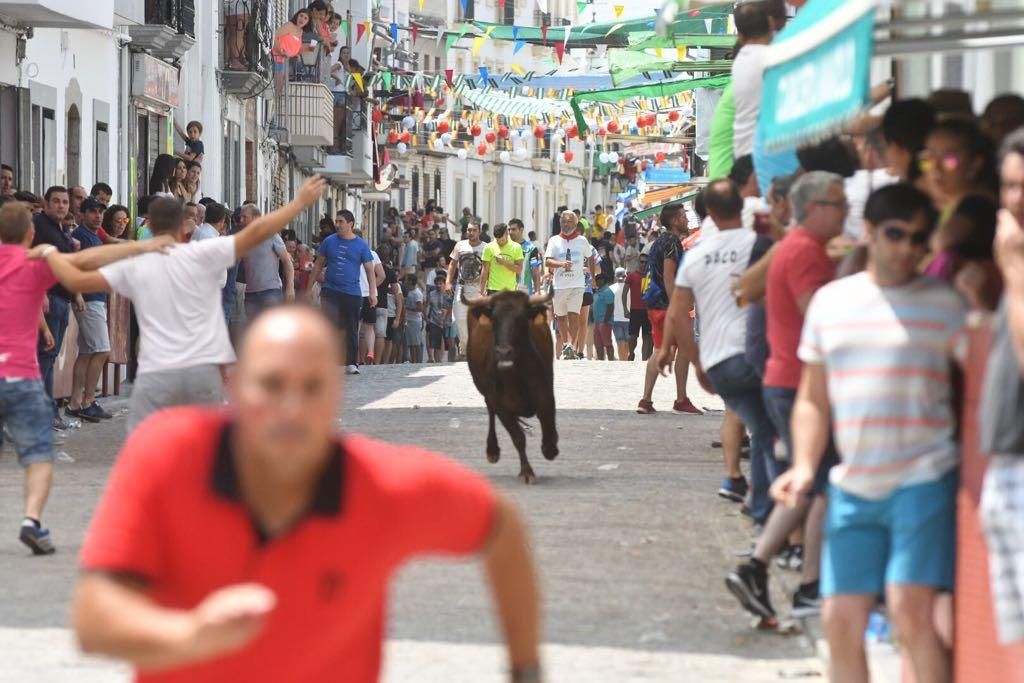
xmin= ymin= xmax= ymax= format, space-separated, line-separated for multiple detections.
xmin=758 ymin=0 xmax=877 ymax=152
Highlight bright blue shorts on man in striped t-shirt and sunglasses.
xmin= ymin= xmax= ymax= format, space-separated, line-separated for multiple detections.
xmin=821 ymin=470 xmax=958 ymax=596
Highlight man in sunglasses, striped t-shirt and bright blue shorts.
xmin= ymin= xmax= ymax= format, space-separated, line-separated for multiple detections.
xmin=772 ymin=184 xmax=967 ymax=681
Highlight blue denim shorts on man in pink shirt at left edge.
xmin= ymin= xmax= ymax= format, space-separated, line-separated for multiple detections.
xmin=0 ymin=379 xmax=53 ymax=466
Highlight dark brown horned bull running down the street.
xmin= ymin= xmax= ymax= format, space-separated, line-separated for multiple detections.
xmin=462 ymin=292 xmax=558 ymax=483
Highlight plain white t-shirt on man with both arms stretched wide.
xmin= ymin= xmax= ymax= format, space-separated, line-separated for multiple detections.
xmin=99 ymin=237 xmax=237 ymax=375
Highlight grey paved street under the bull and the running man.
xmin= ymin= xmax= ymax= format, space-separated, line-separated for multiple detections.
xmin=0 ymin=361 xmax=821 ymax=683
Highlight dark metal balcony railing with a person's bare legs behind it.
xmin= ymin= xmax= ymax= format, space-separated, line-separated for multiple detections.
xmin=221 ymin=0 xmax=273 ymax=79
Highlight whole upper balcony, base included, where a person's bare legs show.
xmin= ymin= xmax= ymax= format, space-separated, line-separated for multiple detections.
xmin=219 ymin=0 xmax=273 ymax=97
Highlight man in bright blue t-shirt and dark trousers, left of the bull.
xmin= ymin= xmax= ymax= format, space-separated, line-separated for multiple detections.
xmin=309 ymin=209 xmax=377 ymax=375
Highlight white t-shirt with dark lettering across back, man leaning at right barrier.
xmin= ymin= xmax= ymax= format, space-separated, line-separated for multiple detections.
xmin=676 ymin=228 xmax=758 ymax=370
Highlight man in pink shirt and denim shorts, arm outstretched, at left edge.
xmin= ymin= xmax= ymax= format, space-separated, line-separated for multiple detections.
xmin=0 ymin=202 xmax=169 ymax=555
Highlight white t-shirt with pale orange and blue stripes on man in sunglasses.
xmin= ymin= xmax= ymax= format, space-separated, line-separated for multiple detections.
xmin=799 ymin=273 xmax=967 ymax=499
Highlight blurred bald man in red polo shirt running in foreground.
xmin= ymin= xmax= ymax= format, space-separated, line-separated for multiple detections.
xmin=73 ymin=306 xmax=540 ymax=683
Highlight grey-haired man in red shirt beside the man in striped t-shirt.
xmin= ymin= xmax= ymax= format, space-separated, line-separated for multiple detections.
xmin=726 ymin=171 xmax=848 ymax=618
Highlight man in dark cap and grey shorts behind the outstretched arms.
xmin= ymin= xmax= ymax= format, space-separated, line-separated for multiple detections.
xmin=65 ymin=197 xmax=113 ymax=422
